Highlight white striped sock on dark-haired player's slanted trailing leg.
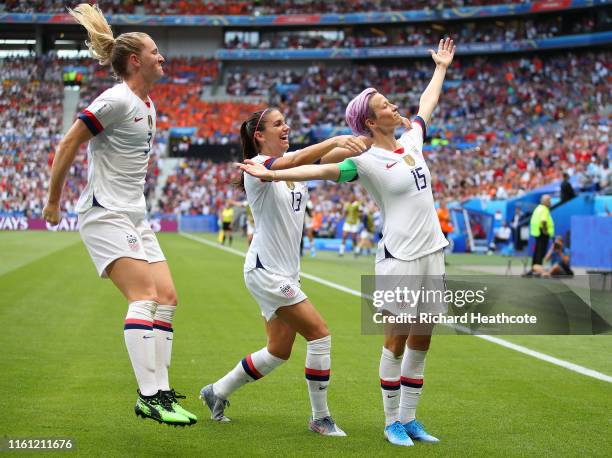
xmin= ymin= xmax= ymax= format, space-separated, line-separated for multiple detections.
xmin=213 ymin=347 xmax=285 ymax=399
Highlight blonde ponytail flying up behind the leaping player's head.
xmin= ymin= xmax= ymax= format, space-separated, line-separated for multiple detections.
xmin=68 ymin=3 xmax=115 ymax=65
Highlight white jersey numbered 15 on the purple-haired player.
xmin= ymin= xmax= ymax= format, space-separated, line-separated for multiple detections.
xmin=351 ymin=118 xmax=448 ymax=262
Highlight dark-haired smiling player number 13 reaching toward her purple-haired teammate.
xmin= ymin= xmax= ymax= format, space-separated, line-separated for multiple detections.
xmin=200 ymin=104 xmax=367 ymax=436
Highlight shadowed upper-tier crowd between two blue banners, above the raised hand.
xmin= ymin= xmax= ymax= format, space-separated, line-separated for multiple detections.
xmin=225 ymin=10 xmax=598 ymax=49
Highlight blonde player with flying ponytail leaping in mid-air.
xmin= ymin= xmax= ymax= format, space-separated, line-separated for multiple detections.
xmin=43 ymin=3 xmax=197 ymax=425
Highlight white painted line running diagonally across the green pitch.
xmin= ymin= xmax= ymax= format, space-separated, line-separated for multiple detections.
xmin=180 ymin=232 xmax=612 ymax=383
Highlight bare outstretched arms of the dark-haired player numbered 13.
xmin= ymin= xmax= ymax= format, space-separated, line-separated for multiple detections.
xmin=270 ymin=135 xmax=371 ymax=170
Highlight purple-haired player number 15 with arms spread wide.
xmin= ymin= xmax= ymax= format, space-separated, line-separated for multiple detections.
xmin=239 ymin=39 xmax=455 ymax=446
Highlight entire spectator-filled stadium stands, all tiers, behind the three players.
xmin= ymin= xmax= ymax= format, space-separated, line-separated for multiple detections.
xmin=0 ymin=0 xmax=612 ymax=240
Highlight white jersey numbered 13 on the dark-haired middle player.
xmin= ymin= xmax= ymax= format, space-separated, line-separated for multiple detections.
xmin=244 ymin=153 xmax=308 ymax=276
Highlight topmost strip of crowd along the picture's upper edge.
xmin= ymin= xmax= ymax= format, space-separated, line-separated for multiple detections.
xmin=3 ymin=0 xmax=520 ymax=15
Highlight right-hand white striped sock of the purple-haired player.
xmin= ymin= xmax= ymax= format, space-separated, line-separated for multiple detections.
xmin=400 ymin=348 xmax=427 ymax=424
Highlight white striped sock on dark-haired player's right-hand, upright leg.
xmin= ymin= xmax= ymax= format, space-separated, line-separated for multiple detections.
xmin=304 ymin=336 xmax=331 ymax=420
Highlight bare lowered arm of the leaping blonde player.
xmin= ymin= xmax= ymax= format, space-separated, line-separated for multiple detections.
xmin=43 ymin=119 xmax=93 ymax=225
